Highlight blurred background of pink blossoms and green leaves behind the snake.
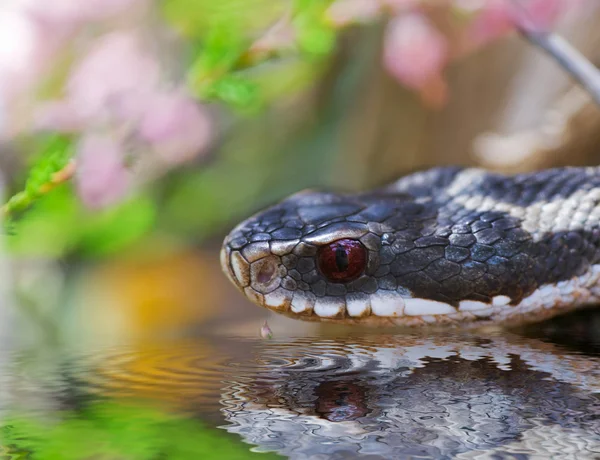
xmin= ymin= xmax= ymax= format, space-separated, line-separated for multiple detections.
xmin=0 ymin=0 xmax=600 ymax=349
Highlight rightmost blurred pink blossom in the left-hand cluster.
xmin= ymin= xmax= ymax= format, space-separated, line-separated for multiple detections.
xmin=138 ymin=92 xmax=212 ymax=163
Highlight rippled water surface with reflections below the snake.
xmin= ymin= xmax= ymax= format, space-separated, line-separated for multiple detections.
xmin=1 ymin=312 xmax=600 ymax=459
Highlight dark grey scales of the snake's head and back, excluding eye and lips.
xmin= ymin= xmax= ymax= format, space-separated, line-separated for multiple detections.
xmin=225 ymin=167 xmax=600 ymax=306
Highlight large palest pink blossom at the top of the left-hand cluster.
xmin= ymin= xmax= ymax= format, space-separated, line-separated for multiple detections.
xmin=67 ymin=32 xmax=159 ymax=119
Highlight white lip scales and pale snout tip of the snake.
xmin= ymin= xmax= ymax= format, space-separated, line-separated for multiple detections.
xmin=221 ymin=239 xmax=600 ymax=326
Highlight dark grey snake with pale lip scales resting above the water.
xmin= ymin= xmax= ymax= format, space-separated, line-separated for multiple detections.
xmin=221 ymin=166 xmax=600 ymax=327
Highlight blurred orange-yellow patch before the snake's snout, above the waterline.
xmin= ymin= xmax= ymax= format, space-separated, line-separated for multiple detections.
xmin=75 ymin=251 xmax=246 ymax=342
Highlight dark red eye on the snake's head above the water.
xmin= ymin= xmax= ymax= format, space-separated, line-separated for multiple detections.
xmin=317 ymin=240 xmax=367 ymax=283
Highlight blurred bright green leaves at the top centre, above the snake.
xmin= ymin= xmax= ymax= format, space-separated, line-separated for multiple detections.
xmin=169 ymin=0 xmax=336 ymax=112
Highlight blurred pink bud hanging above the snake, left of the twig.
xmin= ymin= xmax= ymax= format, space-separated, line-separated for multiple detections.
xmin=383 ymin=13 xmax=448 ymax=89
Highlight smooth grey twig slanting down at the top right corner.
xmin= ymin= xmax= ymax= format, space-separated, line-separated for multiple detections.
xmin=519 ymin=27 xmax=600 ymax=106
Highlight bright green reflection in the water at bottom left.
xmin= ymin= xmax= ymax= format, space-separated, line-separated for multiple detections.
xmin=0 ymin=401 xmax=279 ymax=460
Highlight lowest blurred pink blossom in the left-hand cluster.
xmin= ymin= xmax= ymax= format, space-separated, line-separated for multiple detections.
xmin=76 ymin=134 xmax=131 ymax=209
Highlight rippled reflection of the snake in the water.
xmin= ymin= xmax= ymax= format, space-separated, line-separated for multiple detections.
xmin=216 ymin=336 xmax=600 ymax=459
